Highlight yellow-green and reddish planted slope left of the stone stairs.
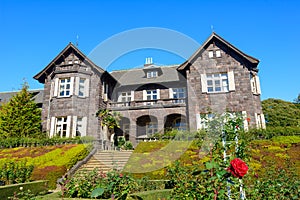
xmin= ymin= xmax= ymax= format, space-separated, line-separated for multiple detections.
xmin=0 ymin=144 xmax=90 ymax=189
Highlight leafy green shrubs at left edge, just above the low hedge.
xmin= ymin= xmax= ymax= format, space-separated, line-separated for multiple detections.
xmin=0 ymin=160 xmax=34 ymax=184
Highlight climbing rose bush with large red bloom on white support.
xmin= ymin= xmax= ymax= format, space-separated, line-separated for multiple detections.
xmin=168 ymin=114 xmax=248 ymax=199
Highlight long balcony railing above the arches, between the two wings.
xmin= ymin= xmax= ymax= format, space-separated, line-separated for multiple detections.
xmin=108 ymin=98 xmax=186 ymax=110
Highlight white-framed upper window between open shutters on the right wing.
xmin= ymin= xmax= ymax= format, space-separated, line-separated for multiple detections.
xmin=206 ymin=73 xmax=229 ymax=92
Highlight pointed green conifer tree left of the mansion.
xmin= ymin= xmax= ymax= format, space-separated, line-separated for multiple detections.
xmin=0 ymin=82 xmax=41 ymax=138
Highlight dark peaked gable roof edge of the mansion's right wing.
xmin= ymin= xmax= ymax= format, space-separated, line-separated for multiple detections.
xmin=178 ymin=32 xmax=259 ymax=70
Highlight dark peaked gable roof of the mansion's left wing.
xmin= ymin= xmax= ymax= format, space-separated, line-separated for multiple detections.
xmin=33 ymin=42 xmax=105 ymax=83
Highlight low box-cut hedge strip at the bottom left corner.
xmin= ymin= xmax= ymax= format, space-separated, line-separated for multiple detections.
xmin=0 ymin=180 xmax=48 ymax=200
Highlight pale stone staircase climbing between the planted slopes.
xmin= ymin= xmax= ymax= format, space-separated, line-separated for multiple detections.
xmin=77 ymin=150 xmax=133 ymax=173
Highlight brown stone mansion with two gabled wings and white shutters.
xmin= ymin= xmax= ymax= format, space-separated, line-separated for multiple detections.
xmin=24 ymin=33 xmax=265 ymax=144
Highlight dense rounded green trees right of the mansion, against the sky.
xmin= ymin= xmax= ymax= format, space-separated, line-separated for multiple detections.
xmin=262 ymin=99 xmax=300 ymax=127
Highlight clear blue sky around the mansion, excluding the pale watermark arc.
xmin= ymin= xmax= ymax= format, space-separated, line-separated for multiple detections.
xmin=0 ymin=0 xmax=300 ymax=101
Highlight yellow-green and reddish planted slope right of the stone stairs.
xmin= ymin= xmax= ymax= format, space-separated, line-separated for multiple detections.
xmin=124 ymin=136 xmax=300 ymax=179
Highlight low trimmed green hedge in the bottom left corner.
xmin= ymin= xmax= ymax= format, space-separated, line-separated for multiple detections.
xmin=0 ymin=180 xmax=48 ymax=200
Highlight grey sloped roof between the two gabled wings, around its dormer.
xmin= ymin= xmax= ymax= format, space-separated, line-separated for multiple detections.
xmin=110 ymin=65 xmax=180 ymax=86
